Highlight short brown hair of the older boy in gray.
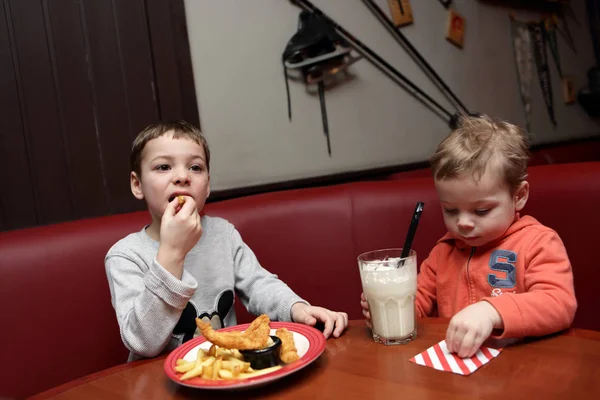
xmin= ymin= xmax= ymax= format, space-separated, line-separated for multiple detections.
xmin=129 ymin=120 xmax=210 ymax=178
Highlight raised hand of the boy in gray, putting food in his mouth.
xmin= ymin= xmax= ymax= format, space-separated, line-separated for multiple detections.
xmin=156 ymin=196 xmax=202 ymax=279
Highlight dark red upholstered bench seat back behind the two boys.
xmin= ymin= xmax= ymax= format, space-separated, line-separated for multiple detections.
xmin=0 ymin=162 xmax=600 ymax=398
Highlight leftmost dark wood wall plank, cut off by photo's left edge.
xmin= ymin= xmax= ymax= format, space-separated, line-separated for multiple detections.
xmin=0 ymin=0 xmax=37 ymax=230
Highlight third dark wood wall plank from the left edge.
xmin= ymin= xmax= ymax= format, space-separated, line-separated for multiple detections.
xmin=45 ymin=0 xmax=109 ymax=219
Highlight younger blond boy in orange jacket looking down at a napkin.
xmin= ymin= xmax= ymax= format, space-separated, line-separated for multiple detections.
xmin=361 ymin=116 xmax=577 ymax=357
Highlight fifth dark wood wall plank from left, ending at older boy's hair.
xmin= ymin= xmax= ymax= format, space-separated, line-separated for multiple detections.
xmin=113 ymin=0 xmax=158 ymax=141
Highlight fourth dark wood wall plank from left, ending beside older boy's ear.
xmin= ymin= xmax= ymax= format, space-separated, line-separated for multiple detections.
xmin=82 ymin=0 xmax=139 ymax=213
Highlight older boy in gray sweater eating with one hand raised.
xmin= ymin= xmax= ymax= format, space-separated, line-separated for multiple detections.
xmin=105 ymin=121 xmax=348 ymax=360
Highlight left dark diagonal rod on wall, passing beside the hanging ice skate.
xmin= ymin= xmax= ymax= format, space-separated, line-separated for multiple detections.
xmin=291 ymin=0 xmax=452 ymax=122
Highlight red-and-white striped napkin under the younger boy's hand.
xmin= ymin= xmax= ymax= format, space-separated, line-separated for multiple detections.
xmin=409 ymin=340 xmax=502 ymax=375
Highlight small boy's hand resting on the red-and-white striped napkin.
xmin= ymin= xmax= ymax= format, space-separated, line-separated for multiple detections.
xmin=446 ymin=301 xmax=503 ymax=358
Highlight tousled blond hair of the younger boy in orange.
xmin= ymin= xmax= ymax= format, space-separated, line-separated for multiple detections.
xmin=430 ymin=115 xmax=529 ymax=191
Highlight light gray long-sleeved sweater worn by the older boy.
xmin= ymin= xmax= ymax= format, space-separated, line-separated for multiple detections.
xmin=105 ymin=216 xmax=305 ymax=361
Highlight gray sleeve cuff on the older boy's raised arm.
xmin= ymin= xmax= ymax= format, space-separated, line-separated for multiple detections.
xmin=144 ymin=259 xmax=198 ymax=309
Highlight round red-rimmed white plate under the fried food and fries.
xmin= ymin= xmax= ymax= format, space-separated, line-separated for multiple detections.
xmin=165 ymin=322 xmax=326 ymax=389
